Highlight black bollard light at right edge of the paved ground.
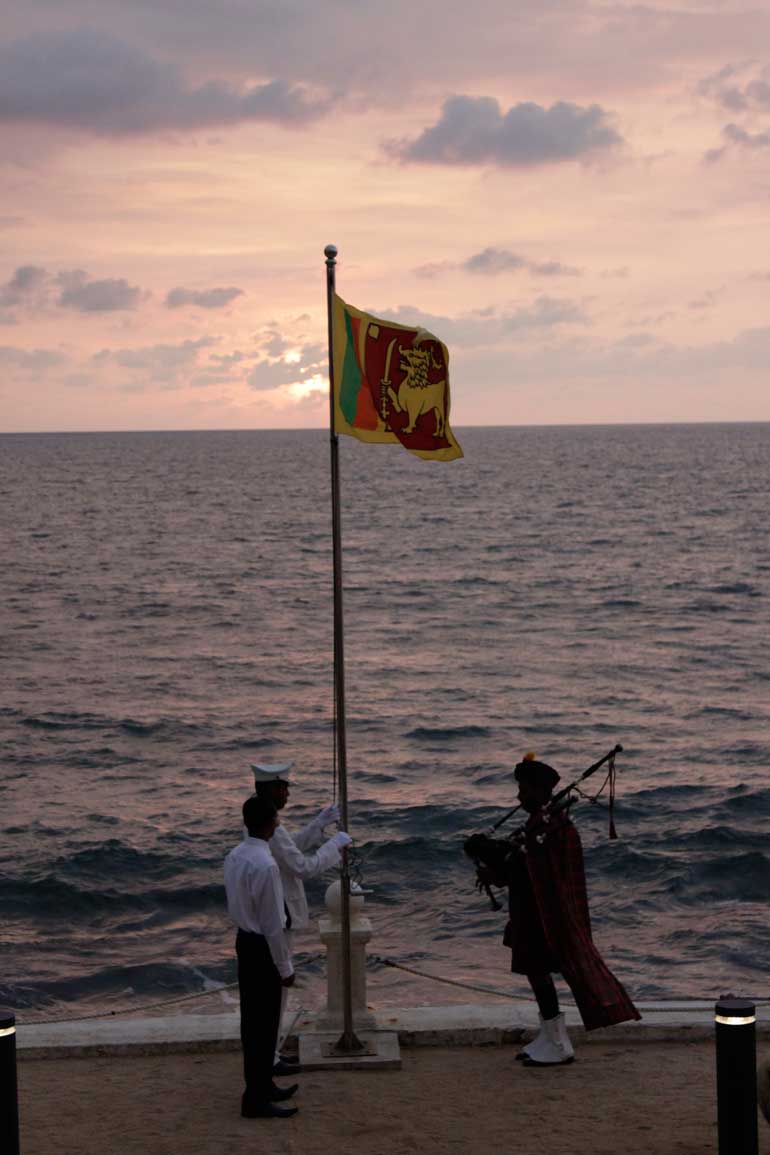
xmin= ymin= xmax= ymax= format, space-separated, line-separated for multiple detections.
xmin=715 ymin=997 xmax=758 ymax=1155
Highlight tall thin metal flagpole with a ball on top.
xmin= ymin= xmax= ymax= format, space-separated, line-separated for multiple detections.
xmin=323 ymin=245 xmax=365 ymax=1055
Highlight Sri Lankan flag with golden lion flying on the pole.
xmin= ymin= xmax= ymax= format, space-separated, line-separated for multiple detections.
xmin=332 ymin=293 xmax=463 ymax=461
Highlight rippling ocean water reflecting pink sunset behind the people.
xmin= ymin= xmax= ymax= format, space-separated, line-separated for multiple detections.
xmin=0 ymin=424 xmax=770 ymax=1021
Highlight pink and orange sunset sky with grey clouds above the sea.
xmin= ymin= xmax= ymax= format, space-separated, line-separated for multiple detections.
xmin=0 ymin=0 xmax=770 ymax=432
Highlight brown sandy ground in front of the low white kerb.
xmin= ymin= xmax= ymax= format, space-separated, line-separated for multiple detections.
xmin=18 ymin=1042 xmax=770 ymax=1155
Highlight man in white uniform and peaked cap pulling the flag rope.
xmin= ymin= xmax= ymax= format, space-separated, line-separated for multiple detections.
xmin=252 ymin=762 xmax=353 ymax=1074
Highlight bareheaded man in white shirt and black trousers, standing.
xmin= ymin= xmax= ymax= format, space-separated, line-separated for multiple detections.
xmin=224 ymin=796 xmax=297 ymax=1119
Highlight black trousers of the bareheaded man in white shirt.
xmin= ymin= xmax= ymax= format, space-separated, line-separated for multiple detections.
xmin=236 ymin=930 xmax=281 ymax=1103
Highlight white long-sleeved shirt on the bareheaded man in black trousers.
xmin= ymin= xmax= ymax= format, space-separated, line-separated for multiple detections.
xmin=225 ymin=835 xmax=294 ymax=978
